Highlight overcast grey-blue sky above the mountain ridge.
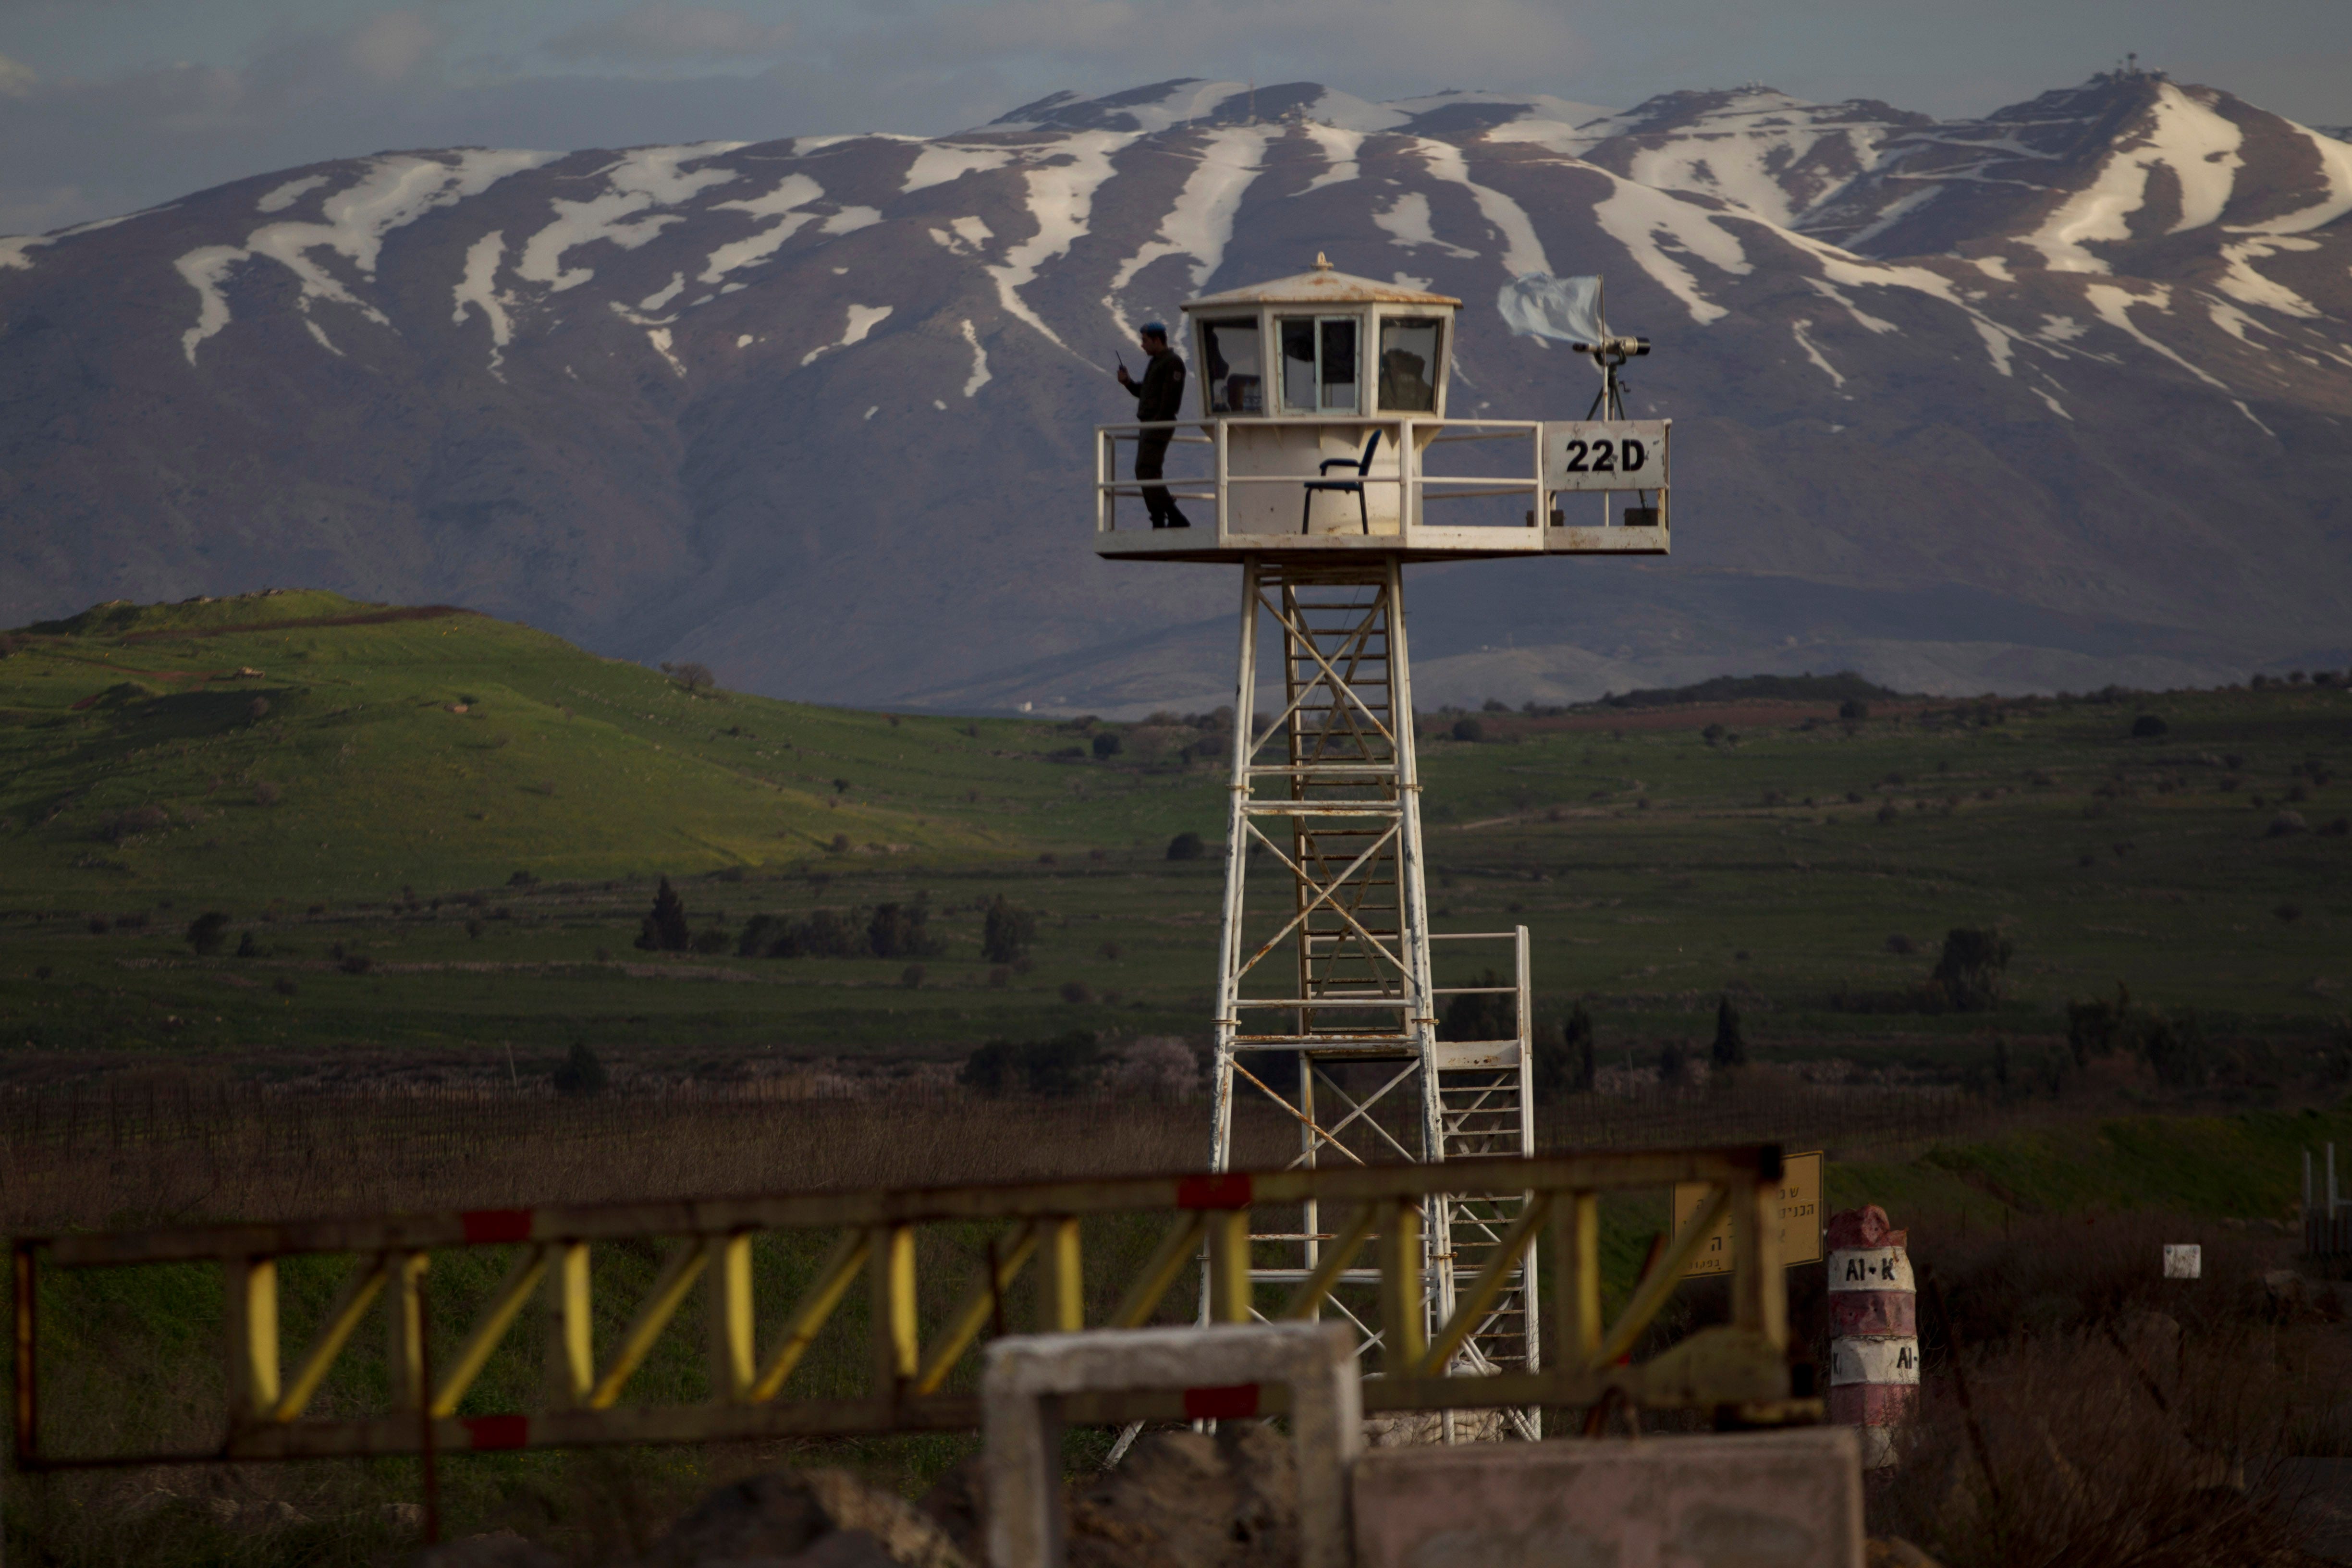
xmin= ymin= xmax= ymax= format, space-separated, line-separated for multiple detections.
xmin=0 ymin=0 xmax=2352 ymax=233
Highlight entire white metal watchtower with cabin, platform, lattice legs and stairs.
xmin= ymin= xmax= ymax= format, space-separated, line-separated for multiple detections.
xmin=1094 ymin=256 xmax=1667 ymax=1436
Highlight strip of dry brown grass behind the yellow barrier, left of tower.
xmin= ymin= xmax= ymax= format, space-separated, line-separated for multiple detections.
xmin=0 ymin=1079 xmax=1286 ymax=1232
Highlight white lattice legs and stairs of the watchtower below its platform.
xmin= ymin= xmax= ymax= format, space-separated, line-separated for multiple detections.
xmin=1204 ymin=557 xmax=1536 ymax=1434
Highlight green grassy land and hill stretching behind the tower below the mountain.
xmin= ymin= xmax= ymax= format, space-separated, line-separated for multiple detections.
xmin=0 ymin=592 xmax=2352 ymax=1074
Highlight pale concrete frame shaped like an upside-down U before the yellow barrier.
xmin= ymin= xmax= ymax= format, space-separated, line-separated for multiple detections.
xmin=981 ymin=1323 xmax=1364 ymax=1568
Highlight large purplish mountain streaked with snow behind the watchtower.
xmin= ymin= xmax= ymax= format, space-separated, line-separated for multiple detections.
xmin=0 ymin=73 xmax=2352 ymax=712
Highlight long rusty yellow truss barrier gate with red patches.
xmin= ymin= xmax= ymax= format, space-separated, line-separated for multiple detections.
xmin=12 ymin=1145 xmax=1809 ymax=1469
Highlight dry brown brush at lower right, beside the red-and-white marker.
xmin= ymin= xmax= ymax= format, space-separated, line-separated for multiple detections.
xmin=1870 ymin=1215 xmax=2352 ymax=1568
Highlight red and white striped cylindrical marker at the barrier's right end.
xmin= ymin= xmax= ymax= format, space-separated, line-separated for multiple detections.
xmin=1825 ymin=1203 xmax=1919 ymax=1469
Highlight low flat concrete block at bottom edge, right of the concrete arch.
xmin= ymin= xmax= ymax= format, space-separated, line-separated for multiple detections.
xmin=1352 ymin=1427 xmax=1863 ymax=1568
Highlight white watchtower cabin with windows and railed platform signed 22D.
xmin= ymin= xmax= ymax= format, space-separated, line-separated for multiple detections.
xmin=1094 ymin=256 xmax=1670 ymax=562
